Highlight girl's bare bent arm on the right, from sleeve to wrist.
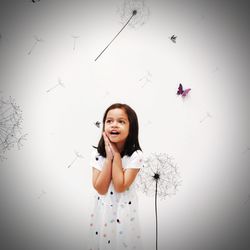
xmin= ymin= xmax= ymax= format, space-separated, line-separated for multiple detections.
xmin=112 ymin=152 xmax=140 ymax=193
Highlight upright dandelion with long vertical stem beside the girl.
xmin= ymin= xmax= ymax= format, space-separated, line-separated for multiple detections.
xmin=137 ymin=153 xmax=181 ymax=250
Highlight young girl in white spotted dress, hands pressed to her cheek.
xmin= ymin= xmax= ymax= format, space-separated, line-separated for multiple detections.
xmin=88 ymin=103 xmax=143 ymax=250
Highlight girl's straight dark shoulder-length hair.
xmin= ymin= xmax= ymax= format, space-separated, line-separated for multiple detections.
xmin=97 ymin=103 xmax=142 ymax=157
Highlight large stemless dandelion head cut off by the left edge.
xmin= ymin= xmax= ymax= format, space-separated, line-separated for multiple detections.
xmin=0 ymin=97 xmax=26 ymax=159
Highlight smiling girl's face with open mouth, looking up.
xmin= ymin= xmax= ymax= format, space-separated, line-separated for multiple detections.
xmin=104 ymin=108 xmax=129 ymax=146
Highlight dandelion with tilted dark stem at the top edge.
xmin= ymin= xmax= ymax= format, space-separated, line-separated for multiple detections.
xmin=95 ymin=0 xmax=149 ymax=61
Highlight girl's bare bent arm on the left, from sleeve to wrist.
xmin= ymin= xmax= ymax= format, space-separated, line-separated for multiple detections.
xmin=92 ymin=158 xmax=112 ymax=195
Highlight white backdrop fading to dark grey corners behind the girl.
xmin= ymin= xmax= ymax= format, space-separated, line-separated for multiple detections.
xmin=0 ymin=0 xmax=250 ymax=250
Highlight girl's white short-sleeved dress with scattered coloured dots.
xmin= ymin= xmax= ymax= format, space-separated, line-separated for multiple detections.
xmin=88 ymin=150 xmax=143 ymax=250
